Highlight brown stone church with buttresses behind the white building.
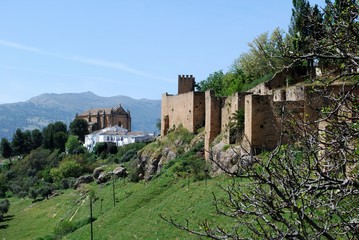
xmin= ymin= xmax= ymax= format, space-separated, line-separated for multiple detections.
xmin=77 ymin=105 xmax=131 ymax=132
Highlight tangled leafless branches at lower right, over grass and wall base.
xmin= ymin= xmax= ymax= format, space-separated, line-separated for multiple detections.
xmin=163 ymin=83 xmax=359 ymax=239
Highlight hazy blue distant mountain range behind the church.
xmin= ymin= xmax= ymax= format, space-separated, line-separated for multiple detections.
xmin=0 ymin=92 xmax=161 ymax=139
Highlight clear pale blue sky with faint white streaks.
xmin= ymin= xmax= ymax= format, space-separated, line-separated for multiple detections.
xmin=0 ymin=0 xmax=324 ymax=104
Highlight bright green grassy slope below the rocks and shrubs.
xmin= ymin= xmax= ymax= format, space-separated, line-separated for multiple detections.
xmin=0 ymin=174 xmax=228 ymax=240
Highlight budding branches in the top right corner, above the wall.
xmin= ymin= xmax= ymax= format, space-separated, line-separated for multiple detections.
xmin=279 ymin=0 xmax=359 ymax=76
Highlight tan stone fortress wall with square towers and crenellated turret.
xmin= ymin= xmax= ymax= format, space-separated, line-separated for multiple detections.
xmin=161 ymin=74 xmax=358 ymax=158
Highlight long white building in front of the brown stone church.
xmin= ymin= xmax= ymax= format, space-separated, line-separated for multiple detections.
xmin=84 ymin=126 xmax=154 ymax=152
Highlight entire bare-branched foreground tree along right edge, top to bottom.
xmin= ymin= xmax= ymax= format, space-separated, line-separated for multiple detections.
xmin=162 ymin=1 xmax=359 ymax=239
